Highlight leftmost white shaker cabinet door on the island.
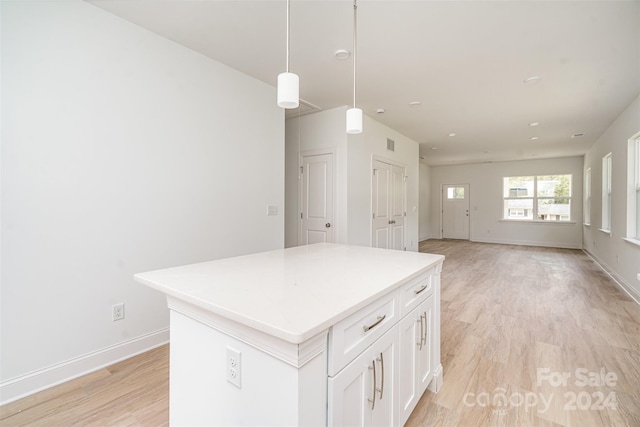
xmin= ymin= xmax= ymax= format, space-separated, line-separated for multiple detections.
xmin=327 ymin=351 xmax=373 ymax=427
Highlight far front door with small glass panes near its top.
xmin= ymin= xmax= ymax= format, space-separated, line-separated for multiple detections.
xmin=442 ymin=184 xmax=469 ymax=240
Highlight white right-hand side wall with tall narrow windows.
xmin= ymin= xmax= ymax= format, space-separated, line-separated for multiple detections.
xmin=583 ymin=97 xmax=640 ymax=302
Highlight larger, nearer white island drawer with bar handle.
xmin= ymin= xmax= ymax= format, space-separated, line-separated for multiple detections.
xmin=328 ymin=291 xmax=399 ymax=377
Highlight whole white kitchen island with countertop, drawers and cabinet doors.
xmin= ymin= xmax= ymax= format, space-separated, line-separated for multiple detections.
xmin=134 ymin=243 xmax=444 ymax=425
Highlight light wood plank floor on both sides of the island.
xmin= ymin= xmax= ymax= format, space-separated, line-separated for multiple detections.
xmin=0 ymin=240 xmax=640 ymax=427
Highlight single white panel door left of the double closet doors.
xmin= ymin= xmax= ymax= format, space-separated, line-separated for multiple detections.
xmin=298 ymin=153 xmax=335 ymax=245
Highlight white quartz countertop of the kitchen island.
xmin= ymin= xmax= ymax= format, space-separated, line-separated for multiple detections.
xmin=134 ymin=243 xmax=444 ymax=344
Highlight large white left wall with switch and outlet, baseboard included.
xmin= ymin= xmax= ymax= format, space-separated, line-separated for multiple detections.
xmin=0 ymin=1 xmax=284 ymax=402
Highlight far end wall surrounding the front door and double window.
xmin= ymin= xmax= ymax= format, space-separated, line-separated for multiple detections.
xmin=430 ymin=157 xmax=583 ymax=248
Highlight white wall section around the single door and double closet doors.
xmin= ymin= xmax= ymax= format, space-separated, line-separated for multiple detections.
xmin=285 ymin=107 xmax=419 ymax=251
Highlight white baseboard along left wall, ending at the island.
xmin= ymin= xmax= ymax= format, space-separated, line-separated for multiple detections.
xmin=0 ymin=328 xmax=169 ymax=406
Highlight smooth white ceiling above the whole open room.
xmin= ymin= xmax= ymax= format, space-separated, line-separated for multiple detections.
xmin=89 ymin=0 xmax=640 ymax=165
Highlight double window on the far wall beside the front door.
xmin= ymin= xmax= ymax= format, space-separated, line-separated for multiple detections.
xmin=503 ymin=175 xmax=571 ymax=221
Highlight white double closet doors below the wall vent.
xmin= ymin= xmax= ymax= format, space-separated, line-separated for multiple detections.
xmin=371 ymin=160 xmax=406 ymax=250
